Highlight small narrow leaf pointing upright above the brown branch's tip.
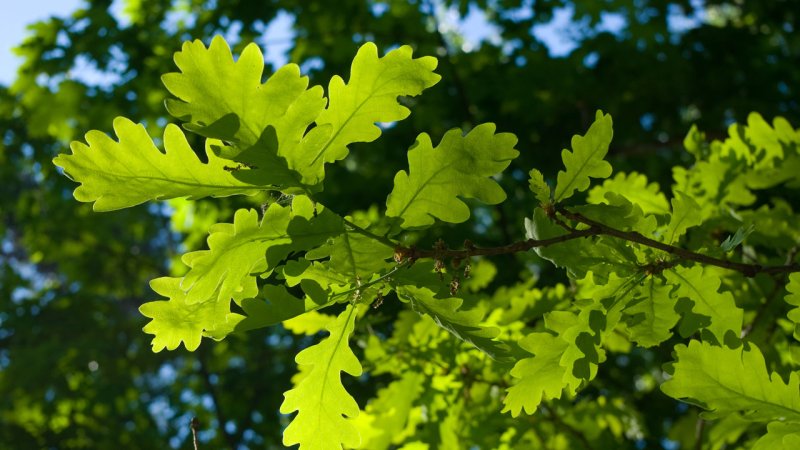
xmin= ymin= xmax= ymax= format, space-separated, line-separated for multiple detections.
xmin=554 ymin=110 xmax=614 ymax=202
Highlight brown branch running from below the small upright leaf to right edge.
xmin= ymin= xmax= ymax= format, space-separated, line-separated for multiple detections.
xmin=555 ymin=205 xmax=800 ymax=277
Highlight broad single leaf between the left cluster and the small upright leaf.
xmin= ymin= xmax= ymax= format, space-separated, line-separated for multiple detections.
xmin=386 ymin=123 xmax=519 ymax=229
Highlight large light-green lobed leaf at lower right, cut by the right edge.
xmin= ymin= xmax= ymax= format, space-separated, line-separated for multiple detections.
xmin=661 ymin=340 xmax=800 ymax=422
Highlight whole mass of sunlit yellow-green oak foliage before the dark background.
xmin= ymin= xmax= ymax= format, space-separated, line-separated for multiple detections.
xmin=48 ymin=33 xmax=800 ymax=449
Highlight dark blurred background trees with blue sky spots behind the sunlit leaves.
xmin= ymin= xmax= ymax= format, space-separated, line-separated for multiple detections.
xmin=0 ymin=0 xmax=800 ymax=449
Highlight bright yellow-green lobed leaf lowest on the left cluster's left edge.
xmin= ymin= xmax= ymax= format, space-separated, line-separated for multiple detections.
xmin=139 ymin=277 xmax=244 ymax=352
